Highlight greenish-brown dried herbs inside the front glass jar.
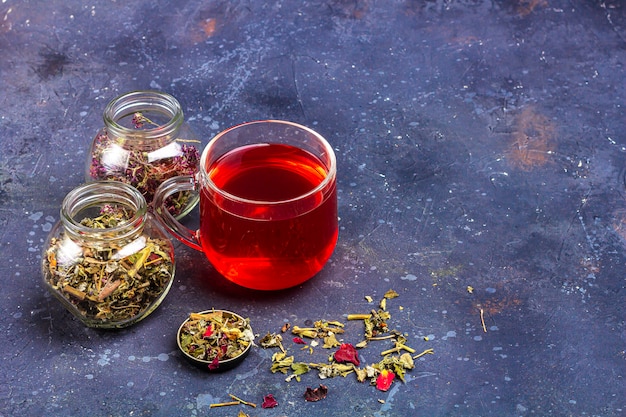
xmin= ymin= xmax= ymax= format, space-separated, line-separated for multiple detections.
xmin=43 ymin=206 xmax=174 ymax=327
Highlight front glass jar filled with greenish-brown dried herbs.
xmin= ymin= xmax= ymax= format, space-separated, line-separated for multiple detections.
xmin=42 ymin=181 xmax=175 ymax=328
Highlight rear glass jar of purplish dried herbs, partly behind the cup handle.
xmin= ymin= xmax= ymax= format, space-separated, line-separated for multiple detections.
xmin=86 ymin=91 xmax=200 ymax=218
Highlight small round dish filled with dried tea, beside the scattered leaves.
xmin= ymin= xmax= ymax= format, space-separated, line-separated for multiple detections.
xmin=178 ymin=310 xmax=254 ymax=370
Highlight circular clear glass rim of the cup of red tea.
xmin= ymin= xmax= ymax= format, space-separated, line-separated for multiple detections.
xmin=198 ymin=119 xmax=337 ymax=206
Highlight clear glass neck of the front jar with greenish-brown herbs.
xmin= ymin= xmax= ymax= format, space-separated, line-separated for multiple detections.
xmin=61 ymin=181 xmax=148 ymax=246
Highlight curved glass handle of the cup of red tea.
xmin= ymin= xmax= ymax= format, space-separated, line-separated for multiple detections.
xmin=152 ymin=176 xmax=202 ymax=251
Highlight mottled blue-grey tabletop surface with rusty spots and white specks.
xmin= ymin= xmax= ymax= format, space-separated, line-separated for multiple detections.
xmin=0 ymin=0 xmax=626 ymax=417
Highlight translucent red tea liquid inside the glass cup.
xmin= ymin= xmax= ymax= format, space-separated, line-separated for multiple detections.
xmin=200 ymin=144 xmax=338 ymax=290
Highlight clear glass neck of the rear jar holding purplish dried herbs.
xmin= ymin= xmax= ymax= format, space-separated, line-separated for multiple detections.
xmin=103 ymin=91 xmax=184 ymax=151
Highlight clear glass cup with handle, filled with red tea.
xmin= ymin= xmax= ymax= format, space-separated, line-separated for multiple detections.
xmin=154 ymin=120 xmax=339 ymax=290
